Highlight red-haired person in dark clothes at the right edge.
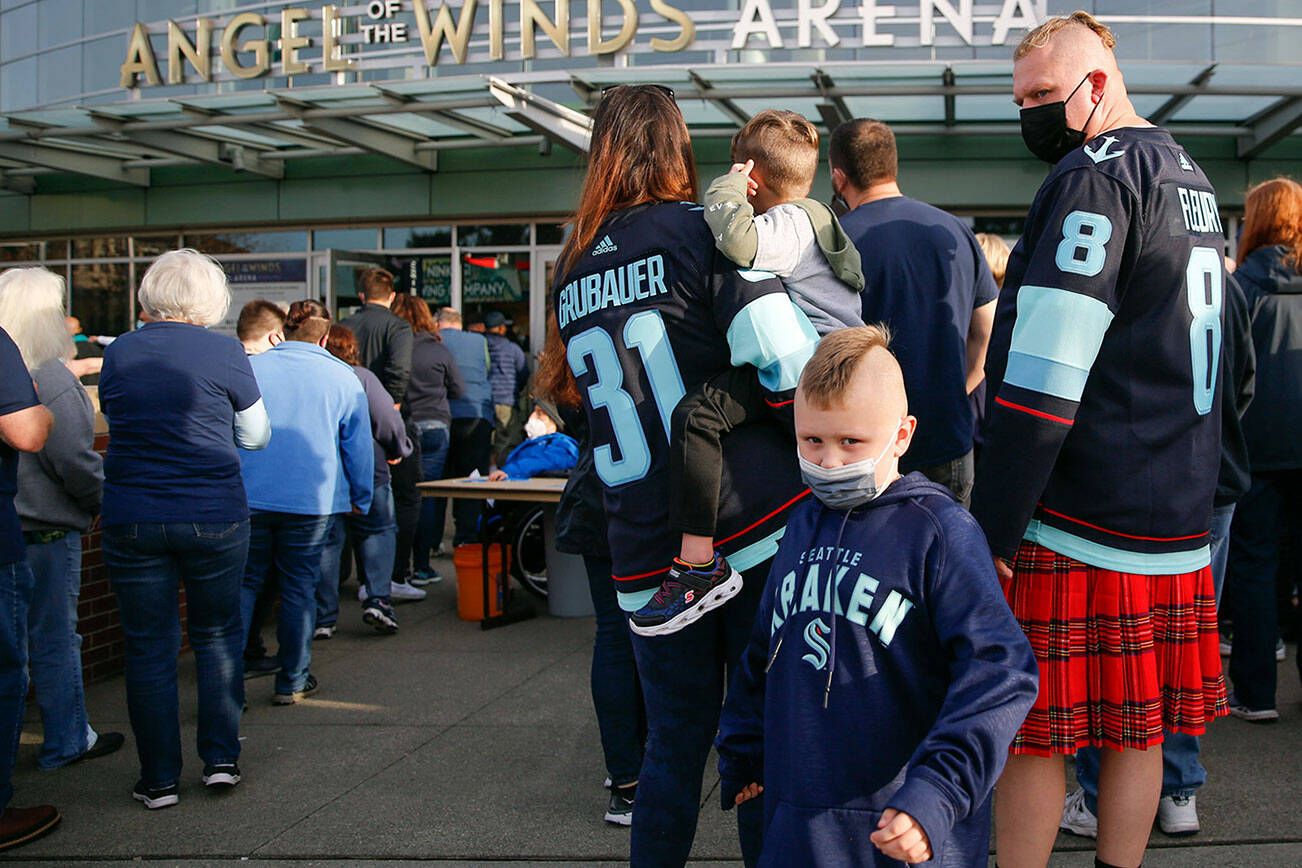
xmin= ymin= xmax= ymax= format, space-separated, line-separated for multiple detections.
xmin=1225 ymin=178 xmax=1302 ymax=722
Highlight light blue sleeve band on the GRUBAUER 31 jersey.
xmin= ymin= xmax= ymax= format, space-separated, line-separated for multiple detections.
xmin=728 ymin=294 xmax=818 ymax=392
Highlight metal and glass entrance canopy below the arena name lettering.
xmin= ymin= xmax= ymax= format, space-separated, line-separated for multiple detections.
xmin=0 ymin=61 xmax=1302 ymax=191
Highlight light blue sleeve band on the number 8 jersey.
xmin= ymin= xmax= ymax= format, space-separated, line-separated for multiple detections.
xmin=1004 ymin=285 xmax=1112 ymax=401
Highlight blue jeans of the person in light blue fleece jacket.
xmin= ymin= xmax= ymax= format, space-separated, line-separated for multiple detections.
xmin=240 ymin=510 xmax=333 ymax=694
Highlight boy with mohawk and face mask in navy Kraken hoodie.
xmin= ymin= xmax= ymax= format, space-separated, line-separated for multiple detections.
xmin=717 ymin=327 xmax=1038 ymax=868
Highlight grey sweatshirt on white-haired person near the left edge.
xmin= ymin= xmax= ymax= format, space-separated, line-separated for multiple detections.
xmin=14 ymin=359 xmax=104 ymax=532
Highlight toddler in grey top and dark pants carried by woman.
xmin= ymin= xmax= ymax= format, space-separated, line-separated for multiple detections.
xmin=630 ymin=109 xmax=863 ymax=636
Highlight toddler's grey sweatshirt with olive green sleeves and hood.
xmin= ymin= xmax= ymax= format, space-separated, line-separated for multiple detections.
xmin=706 ymin=173 xmax=863 ymax=334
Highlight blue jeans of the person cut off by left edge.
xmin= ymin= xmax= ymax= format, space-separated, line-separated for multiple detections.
xmin=0 ymin=561 xmax=33 ymax=811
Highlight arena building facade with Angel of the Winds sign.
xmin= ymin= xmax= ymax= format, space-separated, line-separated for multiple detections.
xmin=0 ymin=0 xmax=1302 ymax=349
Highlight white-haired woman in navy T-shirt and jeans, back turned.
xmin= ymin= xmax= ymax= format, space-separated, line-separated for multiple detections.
xmin=99 ymin=250 xmax=271 ymax=808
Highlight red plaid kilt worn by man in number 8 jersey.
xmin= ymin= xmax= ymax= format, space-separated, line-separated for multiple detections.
xmin=1004 ymin=541 xmax=1229 ymax=756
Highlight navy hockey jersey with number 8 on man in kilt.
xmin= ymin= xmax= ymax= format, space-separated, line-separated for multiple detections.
xmin=973 ymin=128 xmax=1225 ymax=575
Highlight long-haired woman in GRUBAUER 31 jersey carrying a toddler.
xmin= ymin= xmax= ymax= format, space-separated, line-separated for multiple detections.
xmin=544 ymin=85 xmax=814 ymax=867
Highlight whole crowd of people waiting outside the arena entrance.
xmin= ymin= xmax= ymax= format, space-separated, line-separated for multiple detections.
xmin=0 ymin=13 xmax=1302 ymax=868
